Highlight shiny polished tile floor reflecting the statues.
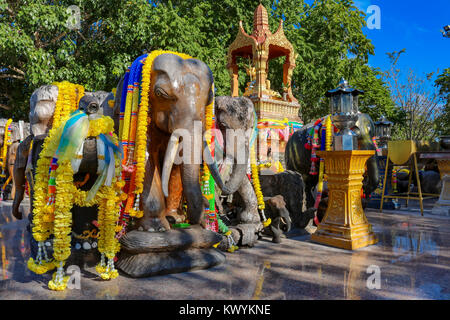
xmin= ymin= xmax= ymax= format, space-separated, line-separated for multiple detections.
xmin=0 ymin=198 xmax=450 ymax=300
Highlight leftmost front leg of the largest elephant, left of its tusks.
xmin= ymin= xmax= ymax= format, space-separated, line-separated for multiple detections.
xmin=137 ymin=155 xmax=170 ymax=232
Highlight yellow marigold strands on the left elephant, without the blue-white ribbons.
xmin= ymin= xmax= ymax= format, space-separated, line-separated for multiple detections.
xmin=27 ymin=82 xmax=123 ymax=290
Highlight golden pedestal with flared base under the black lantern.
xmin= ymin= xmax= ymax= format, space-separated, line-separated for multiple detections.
xmin=311 ymin=150 xmax=378 ymax=250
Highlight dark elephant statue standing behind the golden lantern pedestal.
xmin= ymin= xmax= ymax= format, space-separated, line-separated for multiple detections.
xmin=285 ymin=113 xmax=379 ymax=212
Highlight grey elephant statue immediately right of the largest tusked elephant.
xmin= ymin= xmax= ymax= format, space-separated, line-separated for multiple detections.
xmin=215 ymin=96 xmax=263 ymax=246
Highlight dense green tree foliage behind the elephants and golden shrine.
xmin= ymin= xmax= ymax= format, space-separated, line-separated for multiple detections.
xmin=0 ymin=0 xmax=394 ymax=121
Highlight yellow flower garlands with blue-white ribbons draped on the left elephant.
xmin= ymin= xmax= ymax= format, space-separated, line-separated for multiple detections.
xmin=28 ymin=90 xmax=122 ymax=291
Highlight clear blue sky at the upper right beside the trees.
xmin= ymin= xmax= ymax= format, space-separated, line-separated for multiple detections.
xmin=354 ymin=0 xmax=450 ymax=76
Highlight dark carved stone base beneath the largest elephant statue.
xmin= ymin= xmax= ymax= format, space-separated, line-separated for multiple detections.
xmin=116 ymin=226 xmax=225 ymax=278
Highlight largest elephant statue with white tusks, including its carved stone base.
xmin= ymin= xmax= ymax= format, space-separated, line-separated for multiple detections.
xmin=113 ymin=52 xmax=226 ymax=277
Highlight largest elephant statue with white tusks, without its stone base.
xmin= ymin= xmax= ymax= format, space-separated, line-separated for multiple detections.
xmin=112 ymin=53 xmax=223 ymax=232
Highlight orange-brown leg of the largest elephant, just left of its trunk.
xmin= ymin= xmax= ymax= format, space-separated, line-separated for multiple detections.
xmin=165 ymin=165 xmax=185 ymax=223
